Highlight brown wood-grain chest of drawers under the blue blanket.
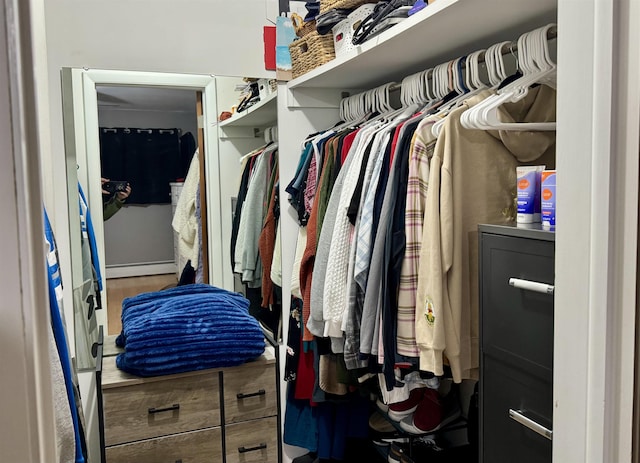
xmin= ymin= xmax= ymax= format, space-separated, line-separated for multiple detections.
xmin=101 ymin=339 xmax=281 ymax=463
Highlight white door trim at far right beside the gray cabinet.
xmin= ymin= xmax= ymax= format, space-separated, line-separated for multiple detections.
xmin=553 ymin=0 xmax=640 ymax=463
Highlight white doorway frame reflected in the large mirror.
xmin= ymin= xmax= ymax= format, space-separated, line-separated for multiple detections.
xmin=63 ymin=68 xmax=224 ymax=331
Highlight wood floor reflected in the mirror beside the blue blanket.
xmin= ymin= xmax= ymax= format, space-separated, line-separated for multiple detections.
xmin=107 ymin=273 xmax=178 ymax=334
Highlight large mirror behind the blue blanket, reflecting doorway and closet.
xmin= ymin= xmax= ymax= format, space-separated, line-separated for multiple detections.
xmin=62 ymin=69 xmax=281 ymax=369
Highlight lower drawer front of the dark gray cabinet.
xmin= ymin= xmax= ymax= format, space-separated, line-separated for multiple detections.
xmin=480 ymin=357 xmax=553 ymax=463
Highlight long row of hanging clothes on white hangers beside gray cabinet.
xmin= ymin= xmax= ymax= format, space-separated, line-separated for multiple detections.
xmin=285 ymin=25 xmax=555 ymax=459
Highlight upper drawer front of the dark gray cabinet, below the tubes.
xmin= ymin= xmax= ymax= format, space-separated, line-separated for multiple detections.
xmin=480 ymin=233 xmax=554 ymax=381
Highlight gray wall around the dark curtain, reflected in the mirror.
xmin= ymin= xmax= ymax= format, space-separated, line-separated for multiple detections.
xmin=98 ymin=105 xmax=198 ymax=267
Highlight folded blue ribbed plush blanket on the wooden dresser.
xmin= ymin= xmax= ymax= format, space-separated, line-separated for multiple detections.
xmin=116 ymin=284 xmax=265 ymax=376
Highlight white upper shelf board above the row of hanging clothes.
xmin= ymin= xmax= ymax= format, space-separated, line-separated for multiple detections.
xmin=287 ymin=0 xmax=557 ymax=89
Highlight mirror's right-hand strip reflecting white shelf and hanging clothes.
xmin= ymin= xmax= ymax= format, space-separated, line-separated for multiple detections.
xmin=216 ymin=77 xmax=282 ymax=340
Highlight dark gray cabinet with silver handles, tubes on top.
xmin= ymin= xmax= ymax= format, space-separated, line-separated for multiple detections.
xmin=479 ymin=225 xmax=555 ymax=463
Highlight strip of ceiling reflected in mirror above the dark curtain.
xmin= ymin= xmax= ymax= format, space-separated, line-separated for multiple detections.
xmin=96 ymin=85 xmax=196 ymax=112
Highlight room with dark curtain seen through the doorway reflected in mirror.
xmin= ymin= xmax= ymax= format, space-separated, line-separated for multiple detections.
xmin=96 ymin=86 xmax=202 ymax=334
